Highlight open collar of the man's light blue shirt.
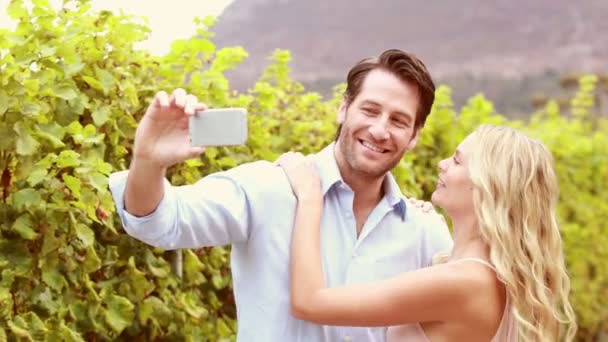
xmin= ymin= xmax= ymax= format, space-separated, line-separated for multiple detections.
xmin=316 ymin=143 xmax=407 ymax=221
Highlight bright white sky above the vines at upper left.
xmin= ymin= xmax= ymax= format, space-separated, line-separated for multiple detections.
xmin=0 ymin=0 xmax=233 ymax=55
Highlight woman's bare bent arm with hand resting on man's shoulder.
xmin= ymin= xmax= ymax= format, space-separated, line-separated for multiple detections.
xmin=280 ymin=154 xmax=484 ymax=327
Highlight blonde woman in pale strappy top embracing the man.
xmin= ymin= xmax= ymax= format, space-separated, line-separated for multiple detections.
xmin=279 ymin=125 xmax=576 ymax=342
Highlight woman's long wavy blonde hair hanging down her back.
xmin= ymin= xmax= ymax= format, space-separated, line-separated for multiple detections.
xmin=467 ymin=125 xmax=576 ymax=342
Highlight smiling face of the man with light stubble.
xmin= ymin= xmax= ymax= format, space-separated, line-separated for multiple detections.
xmin=336 ymin=70 xmax=419 ymax=178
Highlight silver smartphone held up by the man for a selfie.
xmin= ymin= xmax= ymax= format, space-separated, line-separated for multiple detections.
xmin=188 ymin=108 xmax=247 ymax=146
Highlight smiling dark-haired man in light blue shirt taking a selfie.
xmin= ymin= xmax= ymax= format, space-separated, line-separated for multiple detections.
xmin=110 ymin=50 xmax=451 ymax=342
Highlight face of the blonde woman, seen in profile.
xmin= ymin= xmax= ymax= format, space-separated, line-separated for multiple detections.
xmin=431 ymin=135 xmax=474 ymax=217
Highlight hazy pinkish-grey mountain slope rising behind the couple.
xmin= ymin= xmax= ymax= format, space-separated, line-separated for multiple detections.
xmin=214 ymin=0 xmax=608 ymax=115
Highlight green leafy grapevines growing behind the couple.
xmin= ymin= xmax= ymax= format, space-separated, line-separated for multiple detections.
xmin=0 ymin=0 xmax=608 ymax=341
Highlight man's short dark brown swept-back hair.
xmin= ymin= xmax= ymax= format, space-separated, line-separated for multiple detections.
xmin=336 ymin=49 xmax=435 ymax=140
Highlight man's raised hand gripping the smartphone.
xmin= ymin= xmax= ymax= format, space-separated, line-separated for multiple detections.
xmin=133 ymin=89 xmax=207 ymax=169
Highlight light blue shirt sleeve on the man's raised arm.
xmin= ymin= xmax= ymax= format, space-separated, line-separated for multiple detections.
xmin=109 ymin=168 xmax=251 ymax=250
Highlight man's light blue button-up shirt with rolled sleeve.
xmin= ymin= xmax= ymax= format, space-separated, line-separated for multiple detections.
xmin=110 ymin=144 xmax=452 ymax=342
